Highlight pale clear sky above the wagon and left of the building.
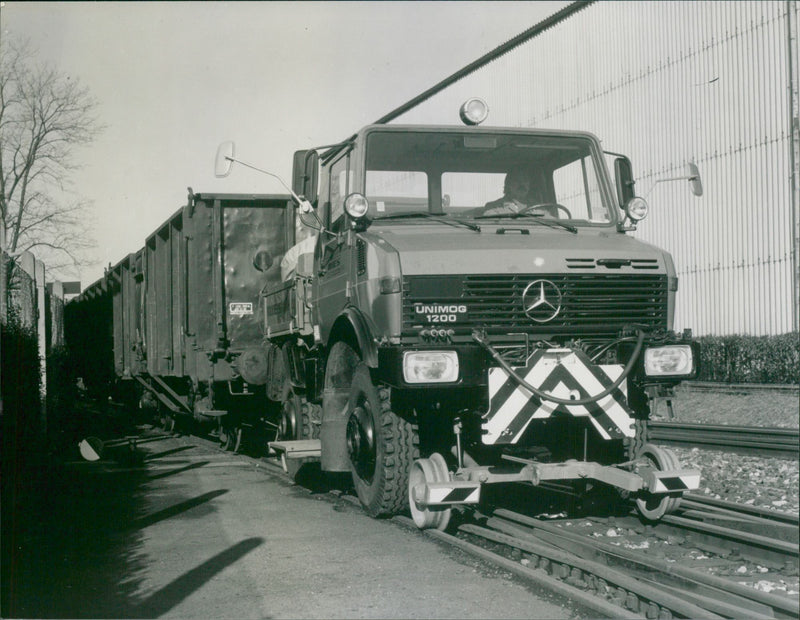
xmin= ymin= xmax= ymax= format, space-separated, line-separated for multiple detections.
xmin=0 ymin=1 xmax=568 ymax=287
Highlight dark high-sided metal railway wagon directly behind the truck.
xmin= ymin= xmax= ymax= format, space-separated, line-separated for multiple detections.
xmin=69 ymin=192 xmax=294 ymax=449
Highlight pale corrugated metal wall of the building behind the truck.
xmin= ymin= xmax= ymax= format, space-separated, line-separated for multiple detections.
xmin=398 ymin=2 xmax=798 ymax=335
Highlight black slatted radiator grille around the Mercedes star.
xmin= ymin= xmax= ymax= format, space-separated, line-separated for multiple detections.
xmin=403 ymin=273 xmax=668 ymax=336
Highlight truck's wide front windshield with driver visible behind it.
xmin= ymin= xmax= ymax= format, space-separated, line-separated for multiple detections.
xmin=365 ymin=131 xmax=613 ymax=225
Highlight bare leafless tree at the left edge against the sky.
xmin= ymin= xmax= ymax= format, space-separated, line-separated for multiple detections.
xmin=0 ymin=37 xmax=102 ymax=270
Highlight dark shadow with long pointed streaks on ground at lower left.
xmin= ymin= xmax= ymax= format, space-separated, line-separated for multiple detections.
xmin=0 ymin=406 xmax=263 ymax=618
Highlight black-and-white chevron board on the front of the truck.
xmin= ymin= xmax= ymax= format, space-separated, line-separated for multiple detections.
xmin=483 ymin=349 xmax=634 ymax=445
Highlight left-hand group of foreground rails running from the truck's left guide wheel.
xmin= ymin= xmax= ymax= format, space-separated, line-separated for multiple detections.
xmin=444 ymin=509 xmax=798 ymax=618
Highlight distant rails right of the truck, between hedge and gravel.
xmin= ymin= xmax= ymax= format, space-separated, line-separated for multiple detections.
xmin=649 ymin=421 xmax=800 ymax=458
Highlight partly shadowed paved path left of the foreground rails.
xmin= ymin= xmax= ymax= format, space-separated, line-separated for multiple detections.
xmin=3 ymin=438 xmax=579 ymax=618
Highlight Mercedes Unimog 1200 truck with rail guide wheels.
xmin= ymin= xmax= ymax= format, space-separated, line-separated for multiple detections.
xmin=218 ymin=100 xmax=700 ymax=529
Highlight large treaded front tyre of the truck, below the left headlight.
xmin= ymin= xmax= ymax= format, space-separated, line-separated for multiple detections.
xmin=347 ymin=363 xmax=419 ymax=517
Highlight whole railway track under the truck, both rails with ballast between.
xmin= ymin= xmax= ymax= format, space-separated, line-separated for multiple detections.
xmin=128 ymin=426 xmax=800 ymax=619
